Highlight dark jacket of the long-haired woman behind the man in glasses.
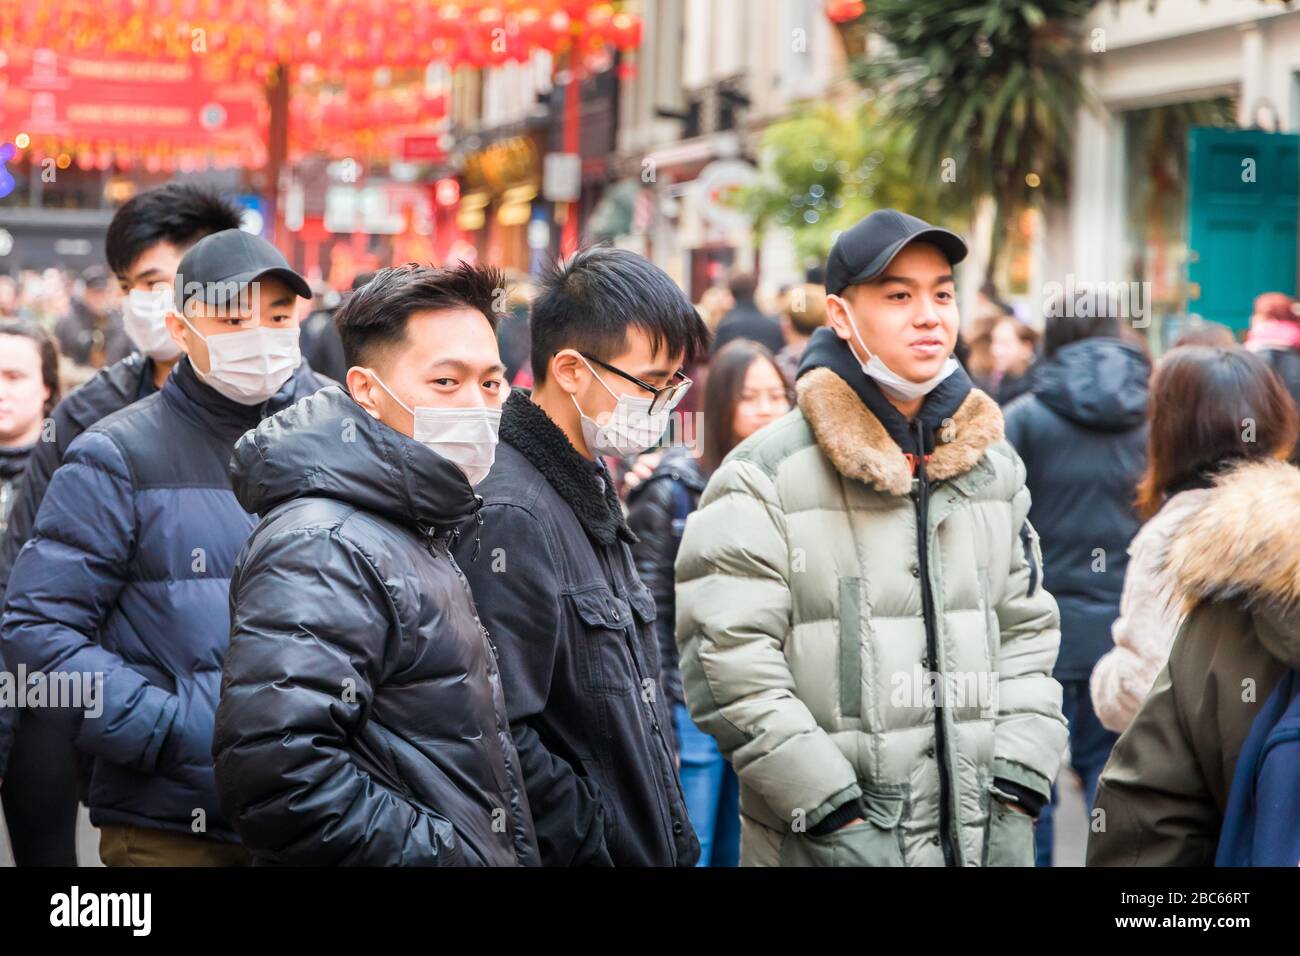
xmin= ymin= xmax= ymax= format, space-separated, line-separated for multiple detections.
xmin=628 ymin=447 xmax=705 ymax=704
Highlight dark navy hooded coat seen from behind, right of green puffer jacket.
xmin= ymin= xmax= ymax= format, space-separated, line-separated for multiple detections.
xmin=1004 ymin=338 xmax=1151 ymax=680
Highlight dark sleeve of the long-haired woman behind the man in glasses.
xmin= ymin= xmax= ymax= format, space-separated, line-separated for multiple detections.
xmin=628 ymin=477 xmax=685 ymax=704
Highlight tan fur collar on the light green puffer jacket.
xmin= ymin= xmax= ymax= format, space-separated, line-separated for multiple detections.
xmin=798 ymin=368 xmax=1002 ymax=496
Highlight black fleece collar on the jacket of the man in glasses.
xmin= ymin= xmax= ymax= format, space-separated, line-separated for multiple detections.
xmin=501 ymin=389 xmax=637 ymax=548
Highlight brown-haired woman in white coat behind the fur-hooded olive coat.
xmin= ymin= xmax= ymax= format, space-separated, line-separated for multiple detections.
xmin=1091 ymin=346 xmax=1295 ymax=734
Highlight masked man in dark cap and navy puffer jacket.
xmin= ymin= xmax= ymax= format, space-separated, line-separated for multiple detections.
xmin=0 ymin=229 xmax=328 ymax=865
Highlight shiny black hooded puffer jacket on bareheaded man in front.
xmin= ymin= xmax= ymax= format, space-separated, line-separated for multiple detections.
xmin=213 ymin=388 xmax=537 ymax=866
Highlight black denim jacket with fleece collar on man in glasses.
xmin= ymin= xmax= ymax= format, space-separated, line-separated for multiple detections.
xmin=456 ymin=389 xmax=699 ymax=866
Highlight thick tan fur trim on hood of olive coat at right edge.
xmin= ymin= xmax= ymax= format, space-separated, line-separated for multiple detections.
xmin=1165 ymin=459 xmax=1300 ymax=667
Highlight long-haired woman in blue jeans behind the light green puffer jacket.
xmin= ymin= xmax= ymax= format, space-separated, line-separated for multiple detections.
xmin=628 ymin=339 xmax=790 ymax=866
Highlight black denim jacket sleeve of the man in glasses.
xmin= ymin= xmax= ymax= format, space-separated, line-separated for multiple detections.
xmin=456 ymin=505 xmax=612 ymax=866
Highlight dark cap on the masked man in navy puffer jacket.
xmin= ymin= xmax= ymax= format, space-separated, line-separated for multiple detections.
xmin=174 ymin=229 xmax=312 ymax=311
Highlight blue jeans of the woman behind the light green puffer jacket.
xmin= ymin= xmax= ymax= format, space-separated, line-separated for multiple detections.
xmin=672 ymin=704 xmax=740 ymax=866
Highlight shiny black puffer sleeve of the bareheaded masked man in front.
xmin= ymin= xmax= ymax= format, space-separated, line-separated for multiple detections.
xmin=212 ymin=528 xmax=464 ymax=866
